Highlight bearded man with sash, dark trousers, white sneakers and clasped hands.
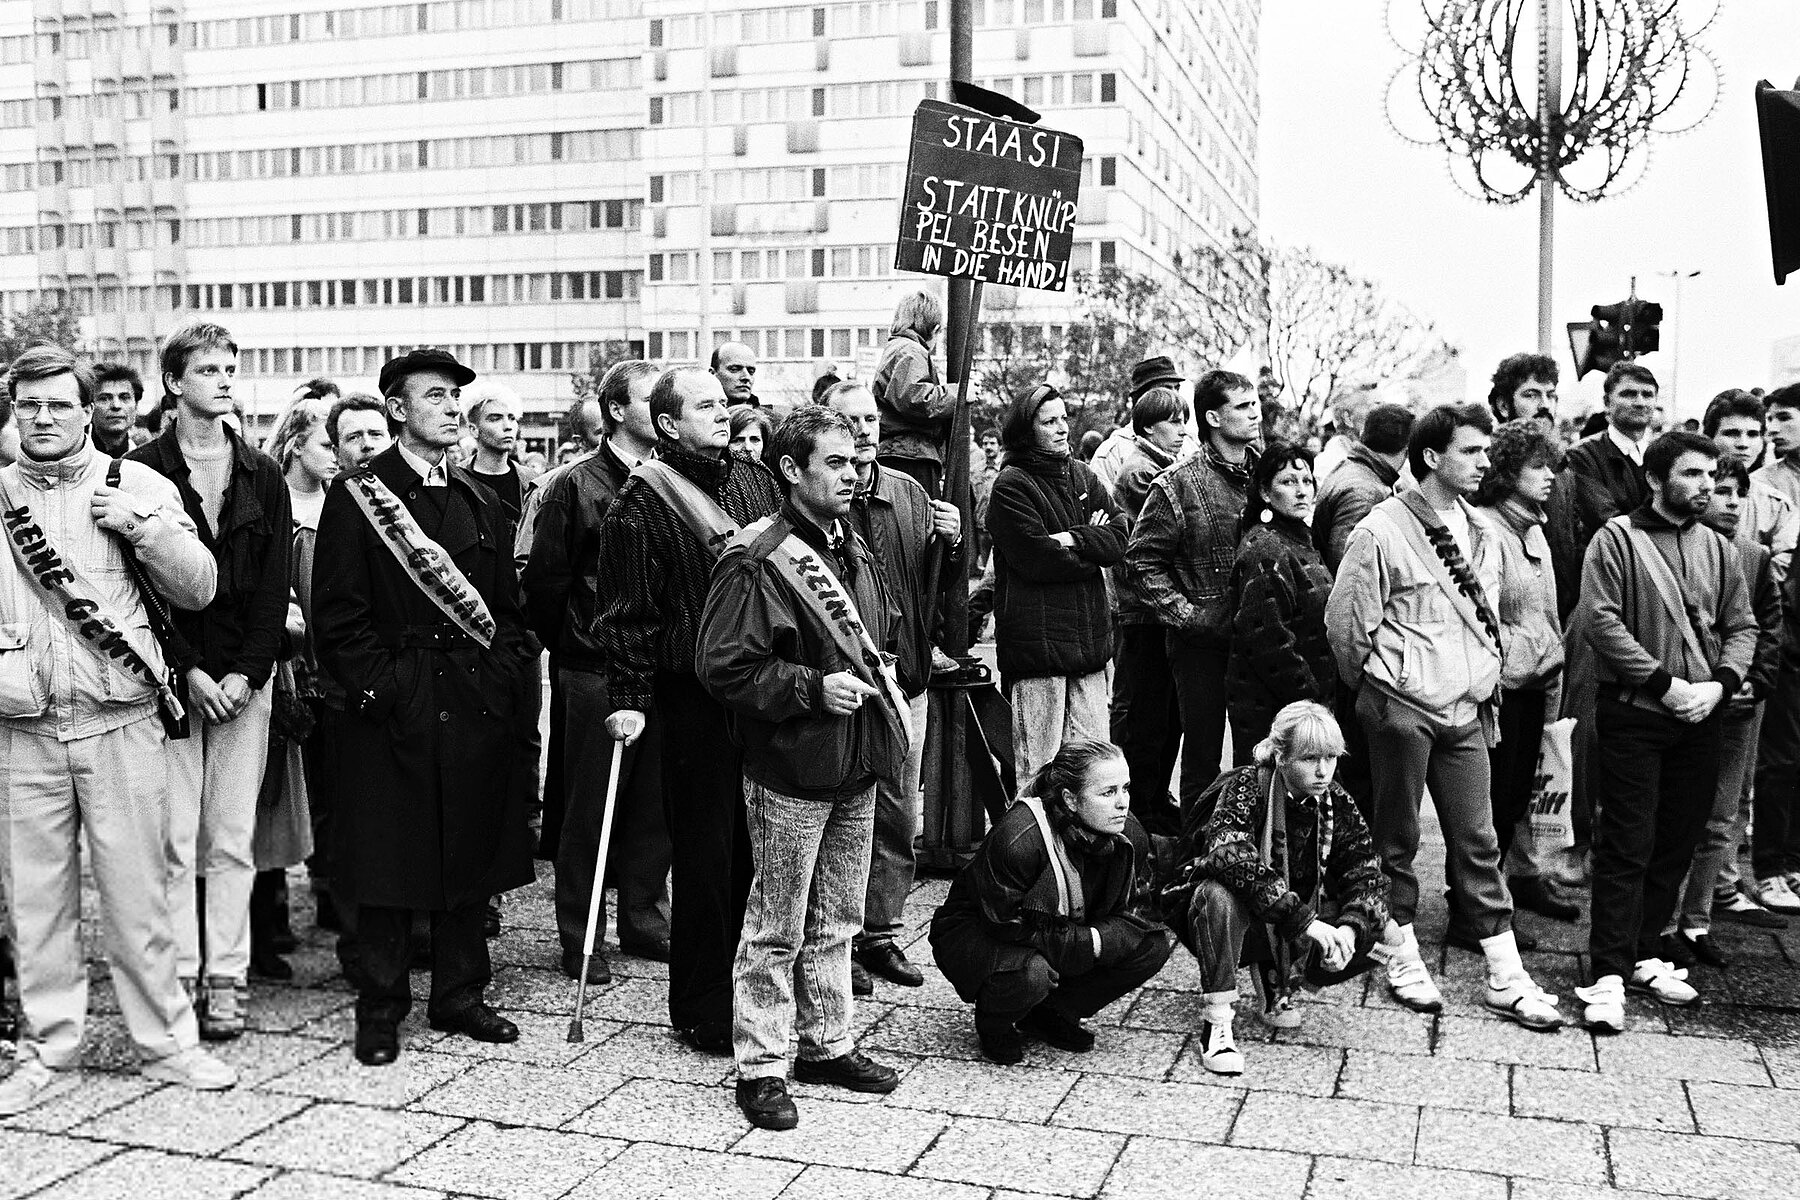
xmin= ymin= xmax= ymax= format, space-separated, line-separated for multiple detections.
xmin=1575 ymin=432 xmax=1757 ymax=1033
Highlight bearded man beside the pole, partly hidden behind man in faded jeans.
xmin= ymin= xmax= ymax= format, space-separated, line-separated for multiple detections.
xmin=823 ymin=381 xmax=963 ymax=995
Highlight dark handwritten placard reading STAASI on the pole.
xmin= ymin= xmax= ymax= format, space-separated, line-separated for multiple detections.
xmin=895 ymin=101 xmax=1082 ymax=291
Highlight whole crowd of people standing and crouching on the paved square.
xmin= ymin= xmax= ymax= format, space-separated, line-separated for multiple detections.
xmin=0 ymin=300 xmax=1800 ymax=1130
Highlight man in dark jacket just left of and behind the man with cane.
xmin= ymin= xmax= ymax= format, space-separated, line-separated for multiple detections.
xmin=524 ymin=362 xmax=670 ymax=982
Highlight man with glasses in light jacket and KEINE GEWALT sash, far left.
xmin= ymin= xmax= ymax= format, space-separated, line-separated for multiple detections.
xmin=0 ymin=347 xmax=238 ymax=1117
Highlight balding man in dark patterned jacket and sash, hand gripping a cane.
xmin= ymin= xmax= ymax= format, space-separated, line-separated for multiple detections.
xmin=592 ymin=367 xmax=781 ymax=1054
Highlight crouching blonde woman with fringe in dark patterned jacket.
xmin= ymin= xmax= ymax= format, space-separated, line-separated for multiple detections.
xmin=1159 ymin=700 xmax=1400 ymax=1076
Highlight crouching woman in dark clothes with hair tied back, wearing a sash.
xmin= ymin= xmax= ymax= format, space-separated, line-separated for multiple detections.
xmin=931 ymin=739 xmax=1175 ymax=1063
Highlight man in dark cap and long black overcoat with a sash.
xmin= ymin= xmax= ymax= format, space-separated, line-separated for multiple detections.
xmin=313 ymin=349 xmax=533 ymax=1067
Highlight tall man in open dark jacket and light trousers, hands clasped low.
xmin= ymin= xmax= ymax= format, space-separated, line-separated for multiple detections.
xmin=130 ymin=322 xmax=293 ymax=1042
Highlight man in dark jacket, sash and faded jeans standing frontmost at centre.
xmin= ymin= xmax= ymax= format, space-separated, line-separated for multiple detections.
xmin=697 ymin=407 xmax=911 ymax=1130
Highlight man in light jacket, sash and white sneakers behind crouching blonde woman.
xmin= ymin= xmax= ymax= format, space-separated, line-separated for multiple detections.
xmin=1325 ymin=405 xmax=1562 ymax=1029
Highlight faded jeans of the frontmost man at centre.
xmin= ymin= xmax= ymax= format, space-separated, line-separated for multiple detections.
xmin=731 ymin=779 xmax=875 ymax=1079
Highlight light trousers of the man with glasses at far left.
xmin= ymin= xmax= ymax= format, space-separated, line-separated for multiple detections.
xmin=0 ymin=714 xmax=200 ymax=1070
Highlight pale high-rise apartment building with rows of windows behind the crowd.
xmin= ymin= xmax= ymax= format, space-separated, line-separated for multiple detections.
xmin=0 ymin=0 xmax=1260 ymax=438
